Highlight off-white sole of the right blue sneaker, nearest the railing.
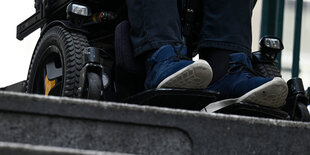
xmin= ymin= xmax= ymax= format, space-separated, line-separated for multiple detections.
xmin=202 ymin=77 xmax=288 ymax=113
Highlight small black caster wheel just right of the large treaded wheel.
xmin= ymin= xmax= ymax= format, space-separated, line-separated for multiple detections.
xmin=86 ymin=72 xmax=102 ymax=100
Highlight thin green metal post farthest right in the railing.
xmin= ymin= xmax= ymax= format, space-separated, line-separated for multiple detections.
xmin=292 ymin=0 xmax=303 ymax=77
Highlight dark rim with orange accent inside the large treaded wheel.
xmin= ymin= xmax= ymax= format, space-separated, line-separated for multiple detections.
xmin=33 ymin=45 xmax=64 ymax=96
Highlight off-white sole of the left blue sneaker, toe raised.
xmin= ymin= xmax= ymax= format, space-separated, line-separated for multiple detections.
xmin=157 ymin=60 xmax=213 ymax=89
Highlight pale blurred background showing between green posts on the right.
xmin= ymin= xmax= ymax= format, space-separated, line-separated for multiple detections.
xmin=252 ymin=0 xmax=310 ymax=89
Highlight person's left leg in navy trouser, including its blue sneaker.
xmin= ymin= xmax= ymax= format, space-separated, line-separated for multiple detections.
xmin=127 ymin=0 xmax=212 ymax=89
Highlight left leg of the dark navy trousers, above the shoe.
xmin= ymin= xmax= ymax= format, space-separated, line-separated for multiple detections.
xmin=126 ymin=0 xmax=182 ymax=56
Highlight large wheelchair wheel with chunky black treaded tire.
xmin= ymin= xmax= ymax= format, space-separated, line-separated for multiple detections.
xmin=26 ymin=26 xmax=89 ymax=97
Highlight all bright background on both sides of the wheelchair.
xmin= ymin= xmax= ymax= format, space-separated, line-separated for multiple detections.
xmin=0 ymin=0 xmax=310 ymax=89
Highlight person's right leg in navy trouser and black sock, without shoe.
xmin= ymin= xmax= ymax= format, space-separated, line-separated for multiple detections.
xmin=198 ymin=0 xmax=256 ymax=82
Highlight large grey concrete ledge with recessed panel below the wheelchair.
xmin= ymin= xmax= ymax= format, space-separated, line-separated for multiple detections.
xmin=0 ymin=92 xmax=310 ymax=154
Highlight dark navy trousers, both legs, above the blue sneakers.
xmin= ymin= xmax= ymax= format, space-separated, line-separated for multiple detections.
xmin=127 ymin=0 xmax=256 ymax=56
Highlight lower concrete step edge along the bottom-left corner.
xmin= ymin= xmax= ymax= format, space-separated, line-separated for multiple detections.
xmin=0 ymin=142 xmax=129 ymax=155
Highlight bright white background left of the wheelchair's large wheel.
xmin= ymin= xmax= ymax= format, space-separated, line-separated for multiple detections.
xmin=0 ymin=0 xmax=40 ymax=87
